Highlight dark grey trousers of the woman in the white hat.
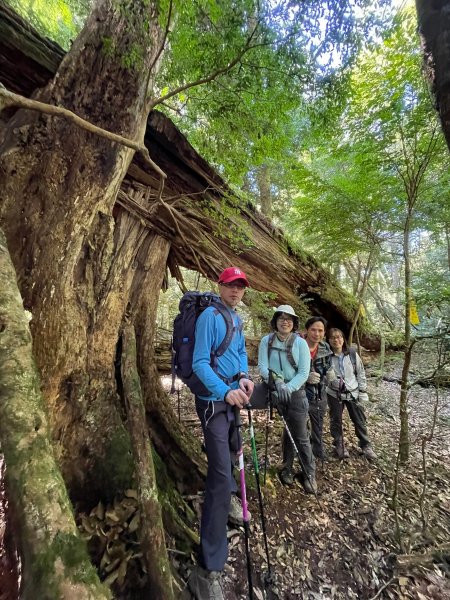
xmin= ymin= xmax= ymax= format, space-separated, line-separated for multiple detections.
xmin=282 ymin=390 xmax=316 ymax=479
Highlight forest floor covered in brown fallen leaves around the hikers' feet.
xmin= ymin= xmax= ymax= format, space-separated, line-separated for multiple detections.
xmin=168 ymin=346 xmax=450 ymax=600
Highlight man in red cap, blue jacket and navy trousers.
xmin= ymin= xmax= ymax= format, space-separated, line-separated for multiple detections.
xmin=188 ymin=267 xmax=253 ymax=600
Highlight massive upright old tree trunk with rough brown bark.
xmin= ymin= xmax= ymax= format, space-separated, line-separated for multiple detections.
xmin=0 ymin=0 xmax=167 ymax=494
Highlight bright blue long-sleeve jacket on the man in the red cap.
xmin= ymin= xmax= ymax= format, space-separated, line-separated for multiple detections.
xmin=192 ymin=306 xmax=248 ymax=400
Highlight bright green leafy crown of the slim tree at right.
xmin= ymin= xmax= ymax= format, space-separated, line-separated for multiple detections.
xmin=284 ymin=3 xmax=449 ymax=322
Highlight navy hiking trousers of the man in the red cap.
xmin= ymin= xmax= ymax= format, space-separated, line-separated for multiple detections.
xmin=195 ymin=398 xmax=238 ymax=571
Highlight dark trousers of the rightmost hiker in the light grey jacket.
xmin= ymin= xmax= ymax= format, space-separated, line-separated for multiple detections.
xmin=327 ymin=393 xmax=370 ymax=448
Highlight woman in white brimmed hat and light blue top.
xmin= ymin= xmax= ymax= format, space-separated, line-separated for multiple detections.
xmin=251 ymin=304 xmax=317 ymax=494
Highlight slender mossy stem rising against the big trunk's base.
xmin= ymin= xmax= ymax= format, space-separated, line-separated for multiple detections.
xmin=121 ymin=323 xmax=174 ymax=600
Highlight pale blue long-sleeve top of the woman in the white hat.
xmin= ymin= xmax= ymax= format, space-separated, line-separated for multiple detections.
xmin=258 ymin=335 xmax=311 ymax=392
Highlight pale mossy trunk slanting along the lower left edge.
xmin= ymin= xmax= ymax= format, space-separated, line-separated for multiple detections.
xmin=0 ymin=230 xmax=111 ymax=600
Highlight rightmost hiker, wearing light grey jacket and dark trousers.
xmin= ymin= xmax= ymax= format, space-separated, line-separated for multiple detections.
xmin=326 ymin=327 xmax=376 ymax=460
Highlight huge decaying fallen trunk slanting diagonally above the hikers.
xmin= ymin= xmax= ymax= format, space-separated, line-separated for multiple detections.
xmin=0 ymin=3 xmax=378 ymax=348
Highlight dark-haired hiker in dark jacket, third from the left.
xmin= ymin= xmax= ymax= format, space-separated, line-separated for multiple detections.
xmin=305 ymin=317 xmax=332 ymax=461
